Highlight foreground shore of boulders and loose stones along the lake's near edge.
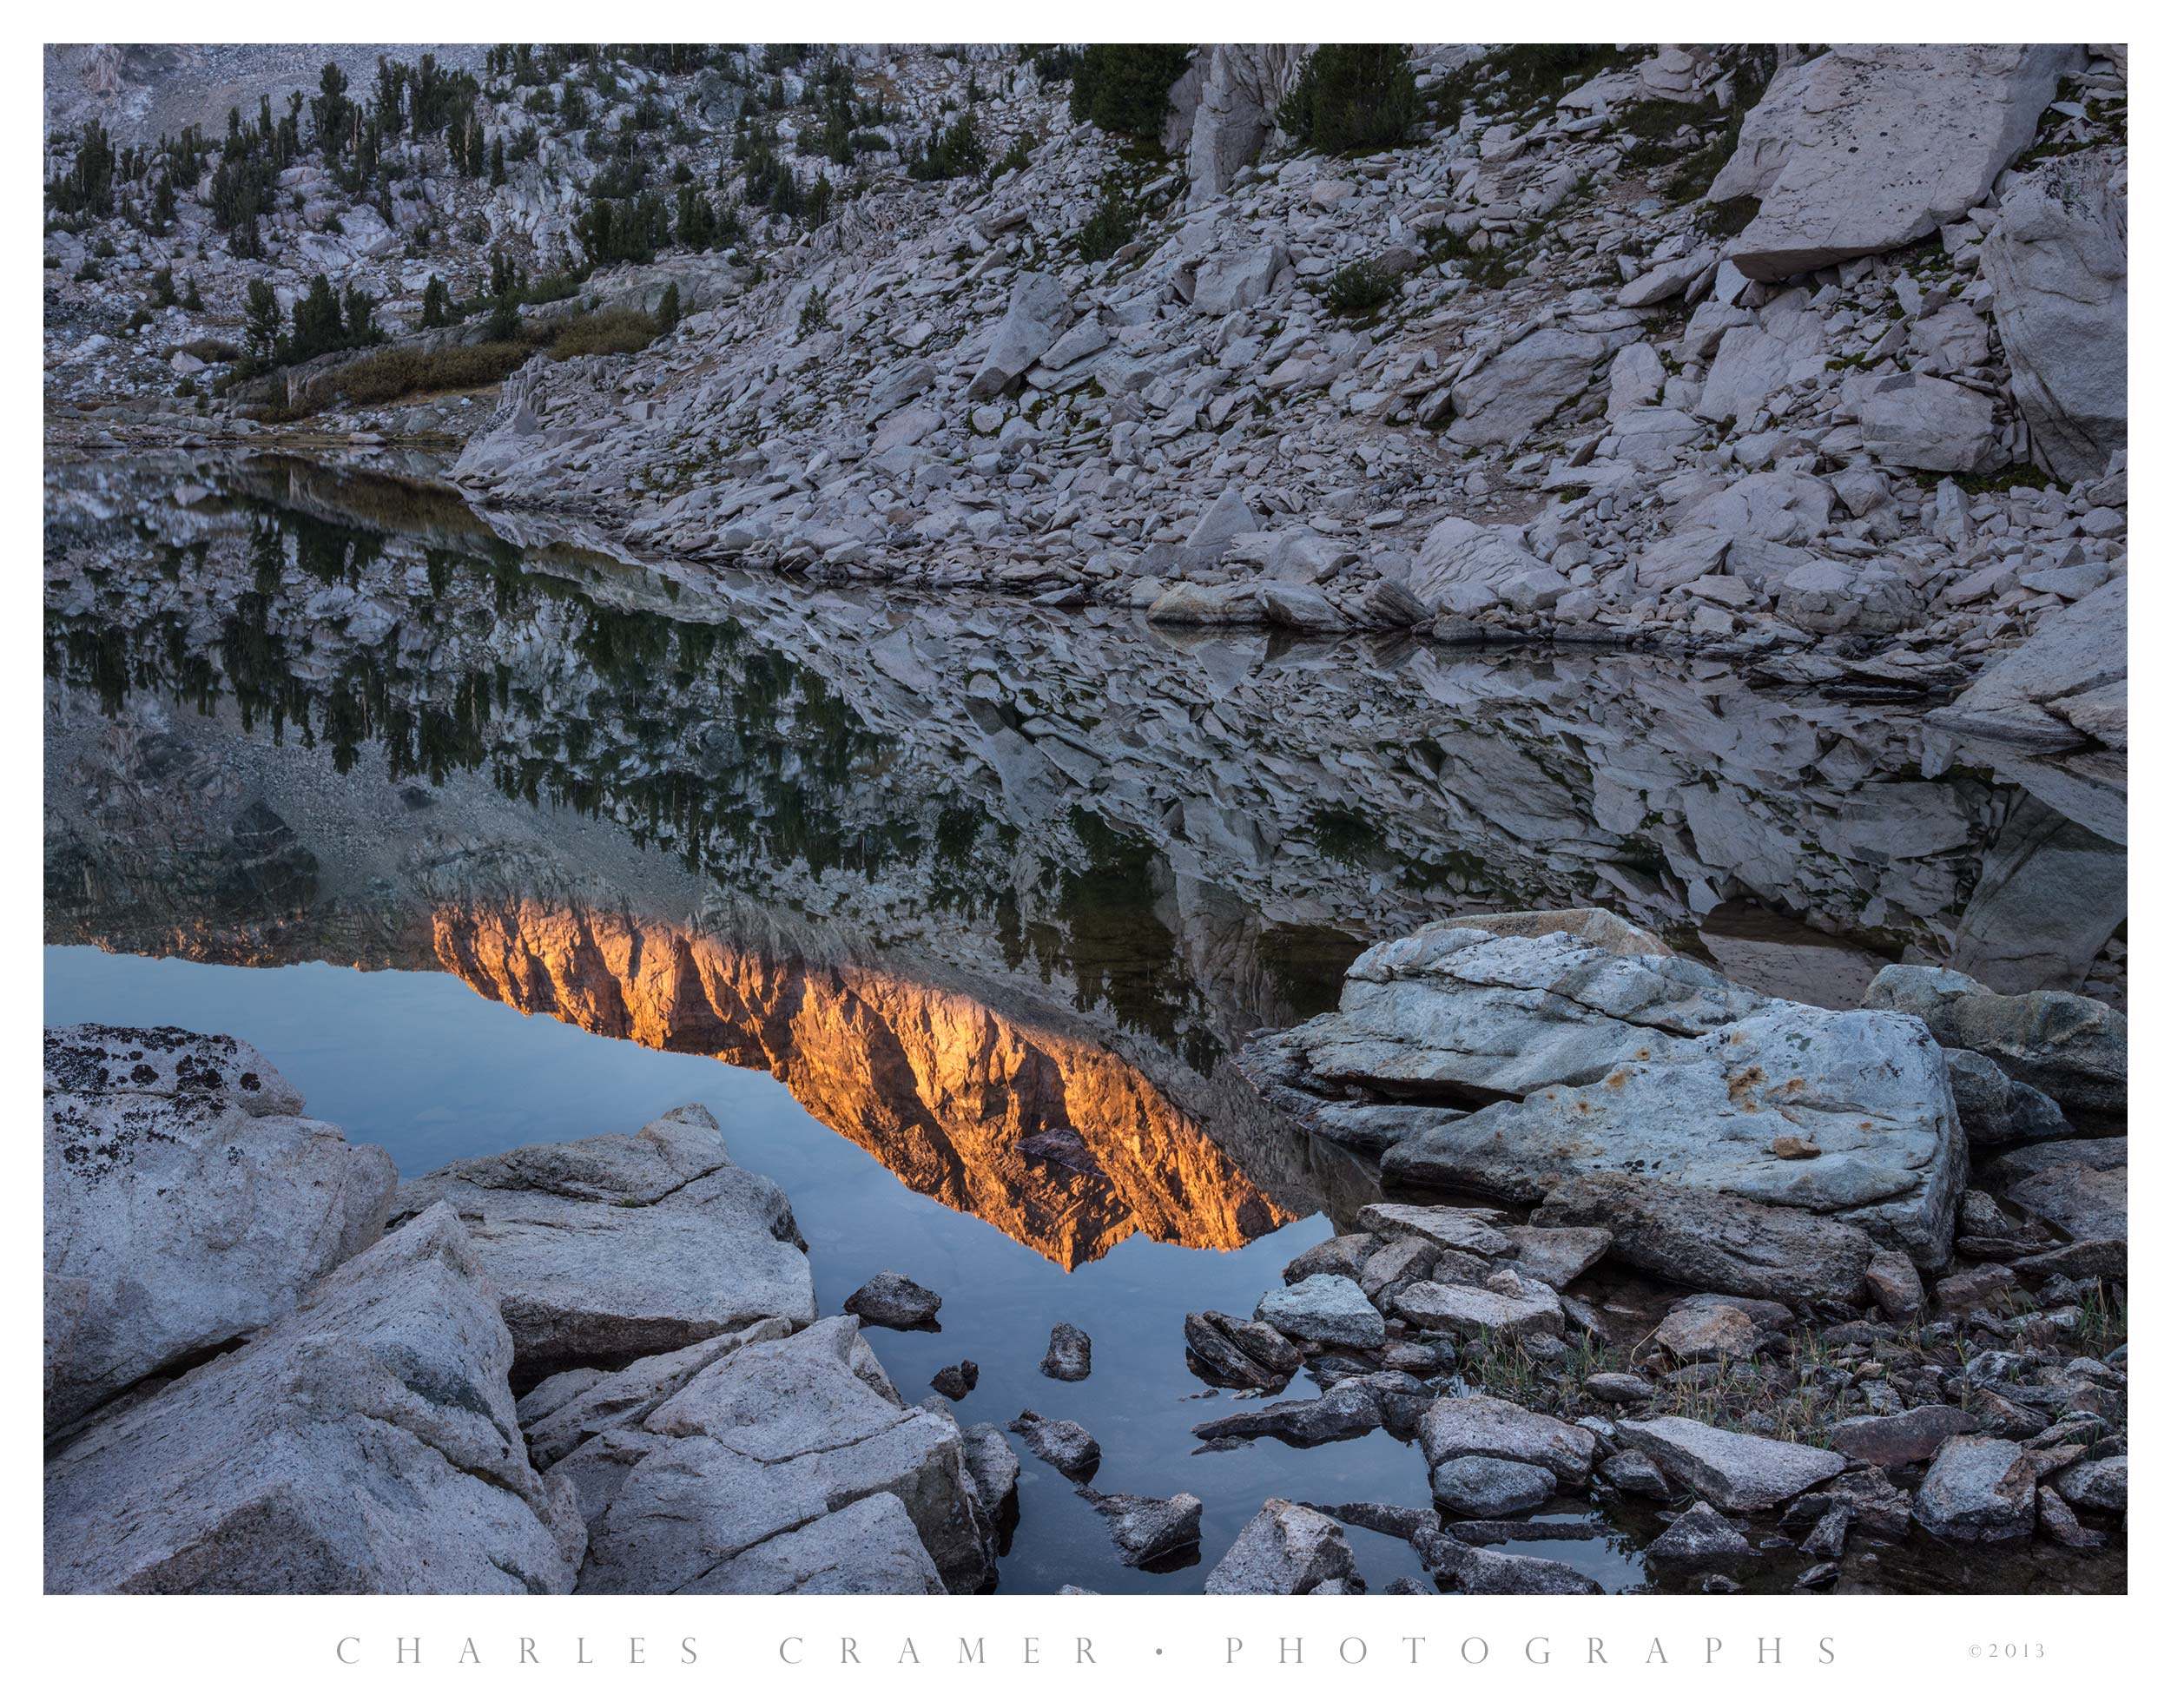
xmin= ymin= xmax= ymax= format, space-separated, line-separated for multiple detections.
xmin=46 ymin=912 xmax=2128 ymax=1593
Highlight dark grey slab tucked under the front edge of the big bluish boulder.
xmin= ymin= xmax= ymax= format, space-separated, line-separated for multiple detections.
xmin=1533 ymin=1174 xmax=1876 ymax=1304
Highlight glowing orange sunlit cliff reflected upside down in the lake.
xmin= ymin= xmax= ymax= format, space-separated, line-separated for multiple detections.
xmin=432 ymin=900 xmax=1290 ymax=1269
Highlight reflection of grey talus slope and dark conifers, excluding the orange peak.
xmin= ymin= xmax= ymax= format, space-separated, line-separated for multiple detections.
xmin=48 ymin=462 xmax=2123 ymax=1002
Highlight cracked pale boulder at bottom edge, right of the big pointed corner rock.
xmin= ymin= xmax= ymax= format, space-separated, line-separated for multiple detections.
xmin=563 ymin=1317 xmax=993 ymax=1595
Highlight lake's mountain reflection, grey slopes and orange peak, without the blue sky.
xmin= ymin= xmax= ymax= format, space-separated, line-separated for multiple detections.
xmin=46 ymin=460 xmax=2126 ymax=1265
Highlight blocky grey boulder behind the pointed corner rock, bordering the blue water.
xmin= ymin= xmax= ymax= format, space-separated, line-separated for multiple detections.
xmin=395 ymin=1105 xmax=815 ymax=1365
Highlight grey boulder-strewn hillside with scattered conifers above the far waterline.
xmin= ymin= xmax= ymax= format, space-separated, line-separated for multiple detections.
xmin=48 ymin=45 xmax=2126 ymax=676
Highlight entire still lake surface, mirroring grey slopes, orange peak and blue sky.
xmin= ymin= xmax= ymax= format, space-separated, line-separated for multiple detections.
xmin=46 ymin=460 xmax=2126 ymax=1593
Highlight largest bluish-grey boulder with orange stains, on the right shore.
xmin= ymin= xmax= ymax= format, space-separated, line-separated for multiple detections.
xmin=1242 ymin=909 xmax=1967 ymax=1258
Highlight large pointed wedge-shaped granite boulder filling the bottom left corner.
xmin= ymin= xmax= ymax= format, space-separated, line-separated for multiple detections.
xmin=46 ymin=1209 xmax=582 ymax=1595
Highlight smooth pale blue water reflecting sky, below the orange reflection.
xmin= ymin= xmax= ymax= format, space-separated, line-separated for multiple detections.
xmin=46 ymin=948 xmax=1641 ymax=1593
